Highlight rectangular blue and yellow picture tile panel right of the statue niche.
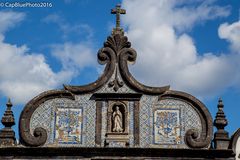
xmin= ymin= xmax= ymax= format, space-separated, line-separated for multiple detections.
xmin=153 ymin=109 xmax=181 ymax=144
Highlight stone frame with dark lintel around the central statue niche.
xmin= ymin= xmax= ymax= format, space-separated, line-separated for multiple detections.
xmin=91 ymin=93 xmax=142 ymax=147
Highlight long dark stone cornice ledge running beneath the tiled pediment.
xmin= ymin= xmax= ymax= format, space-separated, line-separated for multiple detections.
xmin=0 ymin=147 xmax=234 ymax=160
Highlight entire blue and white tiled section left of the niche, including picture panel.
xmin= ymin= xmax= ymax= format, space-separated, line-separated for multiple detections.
xmin=30 ymin=94 xmax=96 ymax=147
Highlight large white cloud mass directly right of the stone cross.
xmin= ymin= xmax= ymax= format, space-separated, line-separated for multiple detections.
xmin=123 ymin=0 xmax=240 ymax=97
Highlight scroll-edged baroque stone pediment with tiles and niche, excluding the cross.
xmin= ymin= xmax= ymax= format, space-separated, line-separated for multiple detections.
xmin=19 ymin=31 xmax=213 ymax=148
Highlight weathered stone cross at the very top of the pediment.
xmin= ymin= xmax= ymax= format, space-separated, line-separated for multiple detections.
xmin=111 ymin=4 xmax=126 ymax=34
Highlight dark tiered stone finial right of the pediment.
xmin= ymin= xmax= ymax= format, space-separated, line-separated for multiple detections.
xmin=213 ymin=98 xmax=230 ymax=149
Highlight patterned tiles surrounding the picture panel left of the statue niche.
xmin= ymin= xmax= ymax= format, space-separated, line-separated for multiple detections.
xmin=30 ymin=94 xmax=96 ymax=147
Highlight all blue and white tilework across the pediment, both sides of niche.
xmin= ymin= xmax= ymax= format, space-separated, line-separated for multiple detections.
xmin=30 ymin=87 xmax=202 ymax=148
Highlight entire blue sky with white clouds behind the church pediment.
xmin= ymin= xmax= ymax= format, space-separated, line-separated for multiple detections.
xmin=0 ymin=0 xmax=240 ymax=139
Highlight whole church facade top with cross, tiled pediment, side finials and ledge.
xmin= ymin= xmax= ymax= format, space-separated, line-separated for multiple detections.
xmin=0 ymin=5 xmax=240 ymax=159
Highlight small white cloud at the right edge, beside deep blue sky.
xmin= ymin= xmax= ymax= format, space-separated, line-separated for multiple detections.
xmin=218 ymin=21 xmax=240 ymax=53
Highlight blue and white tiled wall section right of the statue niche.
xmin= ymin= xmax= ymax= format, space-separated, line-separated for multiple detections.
xmin=140 ymin=95 xmax=202 ymax=148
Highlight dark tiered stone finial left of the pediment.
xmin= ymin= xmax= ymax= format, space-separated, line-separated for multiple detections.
xmin=0 ymin=99 xmax=16 ymax=146
